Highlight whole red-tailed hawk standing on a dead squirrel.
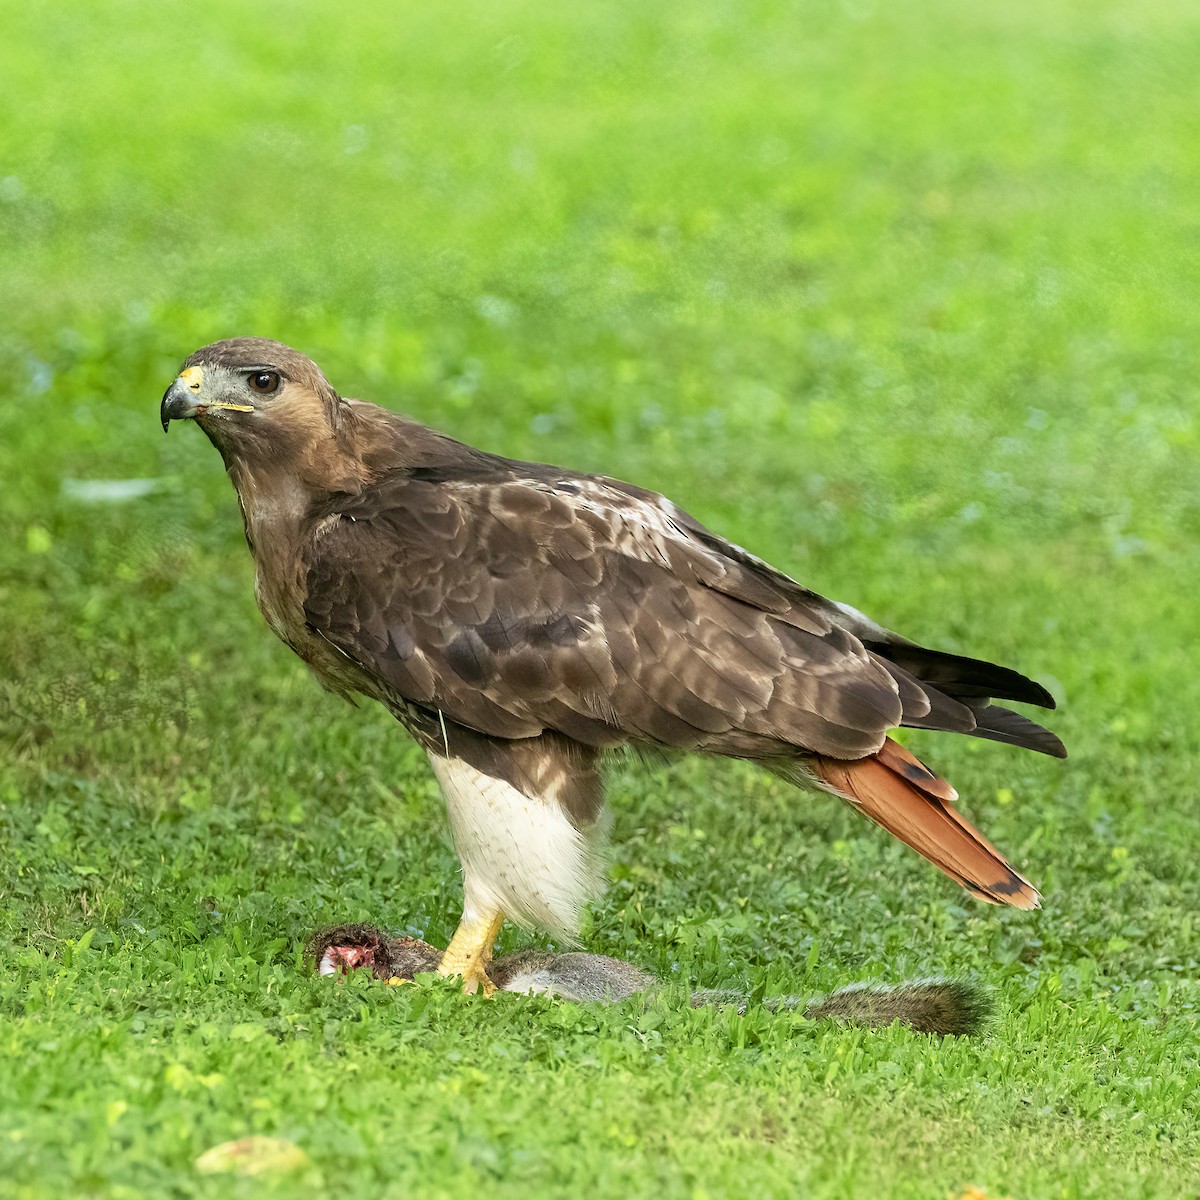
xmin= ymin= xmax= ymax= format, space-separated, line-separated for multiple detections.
xmin=161 ymin=337 xmax=1066 ymax=990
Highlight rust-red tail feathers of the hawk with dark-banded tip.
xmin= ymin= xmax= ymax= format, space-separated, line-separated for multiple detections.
xmin=809 ymin=738 xmax=1038 ymax=908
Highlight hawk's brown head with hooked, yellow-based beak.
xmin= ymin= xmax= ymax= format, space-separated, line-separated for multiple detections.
xmin=160 ymin=337 xmax=342 ymax=461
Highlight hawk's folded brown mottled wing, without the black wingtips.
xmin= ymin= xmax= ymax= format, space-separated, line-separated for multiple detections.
xmin=305 ymin=460 xmax=907 ymax=758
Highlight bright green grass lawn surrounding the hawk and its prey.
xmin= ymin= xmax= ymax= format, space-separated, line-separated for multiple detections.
xmin=0 ymin=0 xmax=1200 ymax=1200
